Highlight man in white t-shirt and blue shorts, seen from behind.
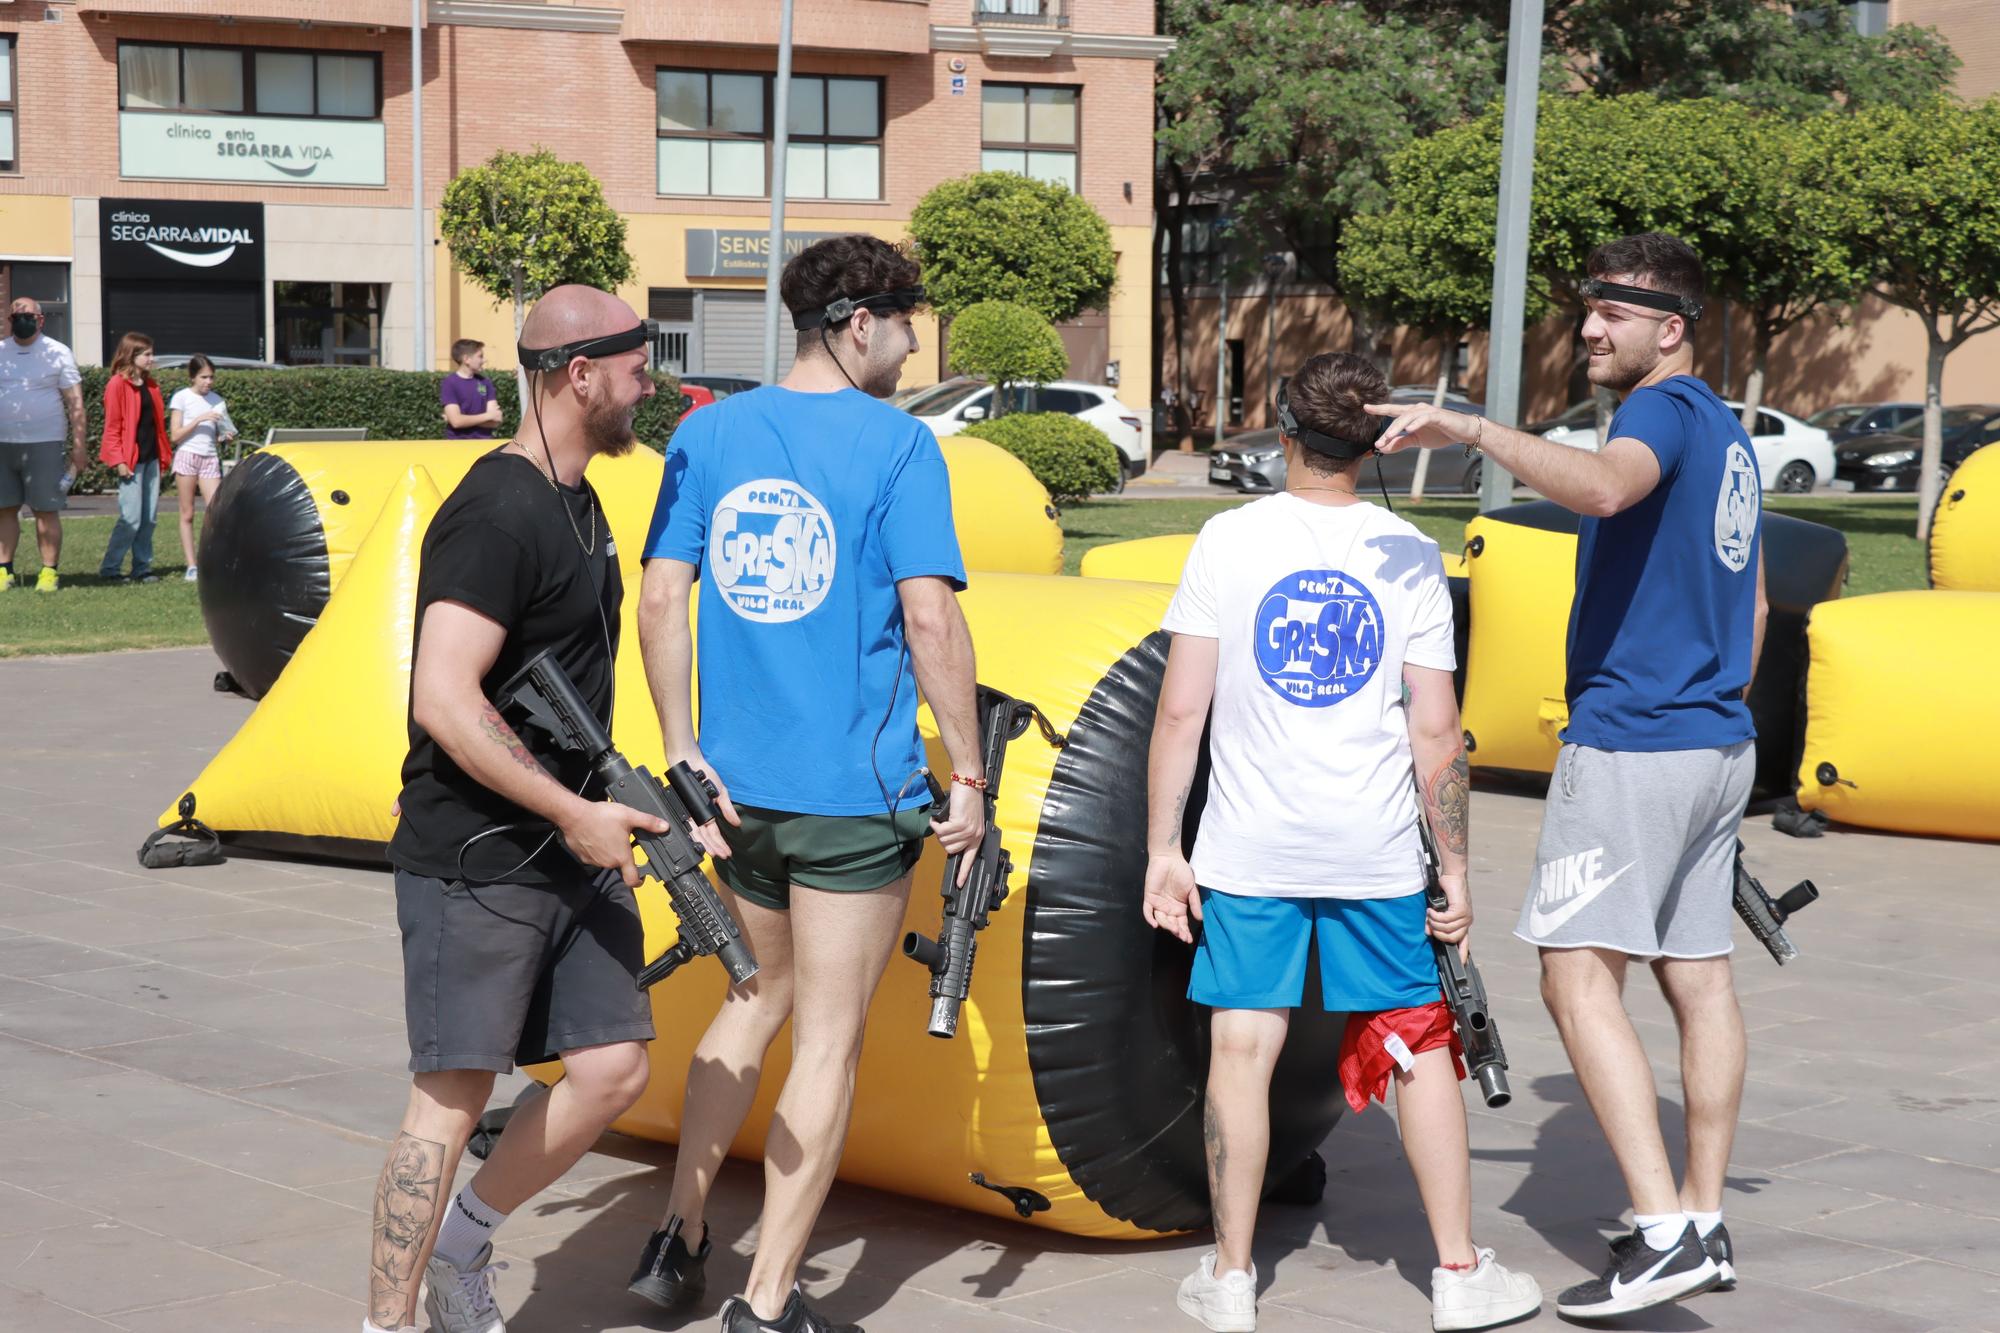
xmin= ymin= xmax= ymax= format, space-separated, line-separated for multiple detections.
xmin=1144 ymin=352 xmax=1542 ymax=1331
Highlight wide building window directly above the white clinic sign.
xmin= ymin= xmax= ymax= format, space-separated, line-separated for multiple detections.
xmin=118 ymin=42 xmax=382 ymax=120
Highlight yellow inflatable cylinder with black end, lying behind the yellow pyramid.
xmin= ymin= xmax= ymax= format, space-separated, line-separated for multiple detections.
xmin=198 ymin=436 xmax=1062 ymax=699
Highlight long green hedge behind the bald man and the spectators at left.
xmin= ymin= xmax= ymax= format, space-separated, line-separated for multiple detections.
xmin=76 ymin=366 xmax=680 ymax=490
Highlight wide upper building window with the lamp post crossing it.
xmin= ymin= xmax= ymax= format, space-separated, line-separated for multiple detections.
xmin=654 ymin=70 xmax=882 ymax=200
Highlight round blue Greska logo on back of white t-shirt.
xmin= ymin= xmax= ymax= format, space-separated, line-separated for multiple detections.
xmin=1254 ymin=568 xmax=1382 ymax=709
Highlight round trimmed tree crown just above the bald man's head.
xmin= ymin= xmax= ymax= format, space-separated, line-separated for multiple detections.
xmin=438 ymin=146 xmax=632 ymax=338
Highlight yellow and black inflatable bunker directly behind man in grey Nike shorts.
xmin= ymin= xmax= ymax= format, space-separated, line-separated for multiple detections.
xmin=1462 ymin=500 xmax=1848 ymax=795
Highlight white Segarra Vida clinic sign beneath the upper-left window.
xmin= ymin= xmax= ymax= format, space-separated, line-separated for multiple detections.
xmin=118 ymin=110 xmax=388 ymax=186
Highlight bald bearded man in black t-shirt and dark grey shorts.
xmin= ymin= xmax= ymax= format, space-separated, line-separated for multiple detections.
xmin=362 ymin=286 xmax=666 ymax=1333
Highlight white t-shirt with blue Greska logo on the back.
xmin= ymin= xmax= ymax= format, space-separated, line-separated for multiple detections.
xmin=1166 ymin=494 xmax=1456 ymax=899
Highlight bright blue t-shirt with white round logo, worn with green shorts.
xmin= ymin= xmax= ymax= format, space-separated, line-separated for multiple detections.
xmin=646 ymin=386 xmax=966 ymax=815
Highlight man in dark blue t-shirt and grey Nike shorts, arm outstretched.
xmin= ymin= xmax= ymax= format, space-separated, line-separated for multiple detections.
xmin=1370 ymin=232 xmax=1764 ymax=1319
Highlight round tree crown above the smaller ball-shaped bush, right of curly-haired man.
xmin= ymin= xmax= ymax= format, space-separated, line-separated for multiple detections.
xmin=910 ymin=172 xmax=1118 ymax=322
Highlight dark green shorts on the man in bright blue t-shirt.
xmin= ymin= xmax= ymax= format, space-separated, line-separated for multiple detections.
xmin=716 ymin=805 xmax=930 ymax=913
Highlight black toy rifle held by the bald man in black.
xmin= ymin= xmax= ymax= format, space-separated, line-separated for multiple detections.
xmin=496 ymin=650 xmax=758 ymax=989
